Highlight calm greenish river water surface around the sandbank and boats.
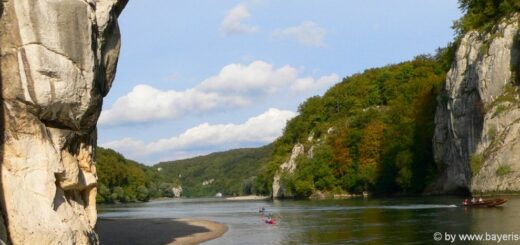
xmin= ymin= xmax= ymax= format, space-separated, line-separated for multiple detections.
xmin=99 ymin=197 xmax=520 ymax=245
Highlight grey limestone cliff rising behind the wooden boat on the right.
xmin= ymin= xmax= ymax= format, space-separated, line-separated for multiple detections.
xmin=433 ymin=15 xmax=520 ymax=192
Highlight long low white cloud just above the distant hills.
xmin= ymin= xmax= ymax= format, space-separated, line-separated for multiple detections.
xmin=100 ymin=108 xmax=296 ymax=163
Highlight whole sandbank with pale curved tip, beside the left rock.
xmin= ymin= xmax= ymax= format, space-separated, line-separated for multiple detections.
xmin=96 ymin=219 xmax=228 ymax=245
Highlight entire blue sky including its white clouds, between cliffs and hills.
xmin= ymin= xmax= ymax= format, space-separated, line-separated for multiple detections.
xmin=98 ymin=0 xmax=461 ymax=164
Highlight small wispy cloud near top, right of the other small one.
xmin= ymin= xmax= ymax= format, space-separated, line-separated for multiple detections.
xmin=273 ymin=21 xmax=327 ymax=47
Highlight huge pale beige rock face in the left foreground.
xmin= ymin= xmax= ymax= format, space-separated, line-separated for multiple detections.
xmin=0 ymin=0 xmax=127 ymax=244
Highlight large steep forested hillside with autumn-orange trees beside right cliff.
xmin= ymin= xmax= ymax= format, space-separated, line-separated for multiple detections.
xmin=255 ymin=54 xmax=453 ymax=196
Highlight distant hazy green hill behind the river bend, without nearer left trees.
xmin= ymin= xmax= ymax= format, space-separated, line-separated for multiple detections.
xmin=154 ymin=145 xmax=273 ymax=197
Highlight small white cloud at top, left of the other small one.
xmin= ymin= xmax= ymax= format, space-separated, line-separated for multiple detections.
xmin=220 ymin=4 xmax=259 ymax=35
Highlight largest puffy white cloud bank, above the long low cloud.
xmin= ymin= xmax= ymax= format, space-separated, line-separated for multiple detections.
xmin=99 ymin=60 xmax=339 ymax=125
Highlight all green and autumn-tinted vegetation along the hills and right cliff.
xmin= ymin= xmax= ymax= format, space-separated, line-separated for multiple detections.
xmin=98 ymin=0 xmax=520 ymax=201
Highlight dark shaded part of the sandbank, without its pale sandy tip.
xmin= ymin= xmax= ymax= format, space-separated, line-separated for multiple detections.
xmin=97 ymin=219 xmax=209 ymax=245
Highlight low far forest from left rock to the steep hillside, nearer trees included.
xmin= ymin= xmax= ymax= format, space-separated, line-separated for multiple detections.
xmin=96 ymin=145 xmax=273 ymax=203
